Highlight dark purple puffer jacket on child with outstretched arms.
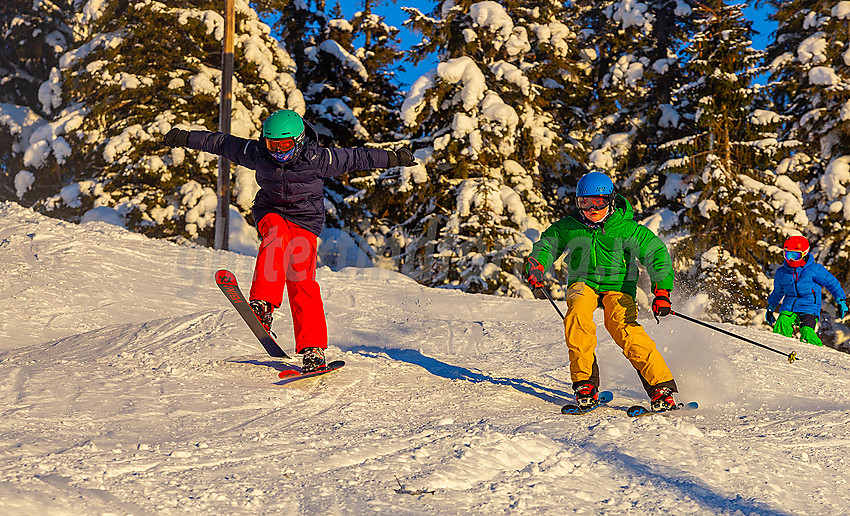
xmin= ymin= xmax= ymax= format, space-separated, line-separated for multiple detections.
xmin=187 ymin=122 xmax=389 ymax=235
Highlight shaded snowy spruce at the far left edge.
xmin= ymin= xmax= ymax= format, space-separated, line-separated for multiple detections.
xmin=0 ymin=0 xmax=74 ymax=204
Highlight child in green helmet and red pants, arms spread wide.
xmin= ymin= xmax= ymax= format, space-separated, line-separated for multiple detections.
xmin=165 ymin=109 xmax=414 ymax=373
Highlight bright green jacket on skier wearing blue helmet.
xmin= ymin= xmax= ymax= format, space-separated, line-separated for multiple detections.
xmin=526 ymin=195 xmax=673 ymax=297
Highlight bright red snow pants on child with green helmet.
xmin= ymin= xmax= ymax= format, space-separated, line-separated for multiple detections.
xmin=249 ymin=213 xmax=328 ymax=353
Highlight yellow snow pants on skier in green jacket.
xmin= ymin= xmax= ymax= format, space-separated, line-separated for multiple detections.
xmin=564 ymin=282 xmax=675 ymax=390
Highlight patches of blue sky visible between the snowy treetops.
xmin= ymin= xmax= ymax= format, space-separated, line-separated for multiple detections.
xmin=336 ymin=0 xmax=776 ymax=90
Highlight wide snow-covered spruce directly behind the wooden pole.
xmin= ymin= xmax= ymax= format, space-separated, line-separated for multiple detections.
xmin=0 ymin=0 xmax=304 ymax=242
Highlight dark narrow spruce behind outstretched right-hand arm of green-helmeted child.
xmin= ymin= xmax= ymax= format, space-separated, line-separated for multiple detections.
xmin=306 ymin=0 xmax=403 ymax=238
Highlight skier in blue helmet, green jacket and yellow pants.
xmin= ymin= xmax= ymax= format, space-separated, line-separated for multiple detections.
xmin=525 ymin=172 xmax=678 ymax=412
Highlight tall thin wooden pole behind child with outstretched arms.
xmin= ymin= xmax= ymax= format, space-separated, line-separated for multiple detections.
xmin=215 ymin=0 xmax=236 ymax=250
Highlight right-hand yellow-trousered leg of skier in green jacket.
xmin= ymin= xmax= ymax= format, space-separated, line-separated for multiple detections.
xmin=602 ymin=292 xmax=678 ymax=397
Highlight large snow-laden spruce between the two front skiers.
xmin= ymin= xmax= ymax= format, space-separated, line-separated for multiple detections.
xmin=372 ymin=1 xmax=557 ymax=296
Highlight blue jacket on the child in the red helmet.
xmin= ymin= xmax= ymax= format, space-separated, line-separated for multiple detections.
xmin=767 ymin=255 xmax=845 ymax=317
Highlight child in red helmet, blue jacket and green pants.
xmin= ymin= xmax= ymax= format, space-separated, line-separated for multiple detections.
xmin=764 ymin=236 xmax=847 ymax=346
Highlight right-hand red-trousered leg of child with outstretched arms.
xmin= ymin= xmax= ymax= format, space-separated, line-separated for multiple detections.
xmin=284 ymin=221 xmax=328 ymax=353
